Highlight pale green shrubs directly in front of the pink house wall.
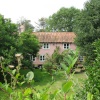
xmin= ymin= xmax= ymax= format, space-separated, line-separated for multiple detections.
xmin=43 ymin=47 xmax=78 ymax=74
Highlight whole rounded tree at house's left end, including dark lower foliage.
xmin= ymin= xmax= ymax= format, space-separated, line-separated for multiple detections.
xmin=18 ymin=31 xmax=40 ymax=68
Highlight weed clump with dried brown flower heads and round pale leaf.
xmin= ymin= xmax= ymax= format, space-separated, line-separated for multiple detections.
xmin=0 ymin=54 xmax=34 ymax=100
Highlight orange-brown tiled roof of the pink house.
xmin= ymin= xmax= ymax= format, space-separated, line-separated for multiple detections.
xmin=33 ymin=32 xmax=76 ymax=42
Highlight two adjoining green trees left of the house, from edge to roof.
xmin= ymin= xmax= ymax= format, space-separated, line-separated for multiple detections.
xmin=0 ymin=15 xmax=39 ymax=66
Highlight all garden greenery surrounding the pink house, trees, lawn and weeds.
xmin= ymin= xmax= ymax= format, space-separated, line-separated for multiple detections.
xmin=0 ymin=0 xmax=100 ymax=100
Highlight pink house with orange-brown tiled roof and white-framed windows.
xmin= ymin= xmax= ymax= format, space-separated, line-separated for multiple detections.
xmin=33 ymin=32 xmax=76 ymax=66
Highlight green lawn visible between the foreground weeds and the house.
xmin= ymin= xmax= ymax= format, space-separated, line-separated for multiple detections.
xmin=0 ymin=69 xmax=86 ymax=100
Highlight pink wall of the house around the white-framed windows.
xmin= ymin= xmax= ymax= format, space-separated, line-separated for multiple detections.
xmin=33 ymin=43 xmax=76 ymax=65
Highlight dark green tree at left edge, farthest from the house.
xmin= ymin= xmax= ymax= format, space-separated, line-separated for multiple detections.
xmin=0 ymin=15 xmax=18 ymax=64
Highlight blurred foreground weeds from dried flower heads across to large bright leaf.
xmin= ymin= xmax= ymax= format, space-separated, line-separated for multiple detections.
xmin=0 ymin=54 xmax=72 ymax=100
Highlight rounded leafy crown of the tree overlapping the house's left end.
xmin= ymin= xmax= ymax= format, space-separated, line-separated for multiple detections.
xmin=19 ymin=32 xmax=39 ymax=56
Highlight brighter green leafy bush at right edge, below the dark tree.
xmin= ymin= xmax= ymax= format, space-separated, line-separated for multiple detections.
xmin=86 ymin=39 xmax=100 ymax=100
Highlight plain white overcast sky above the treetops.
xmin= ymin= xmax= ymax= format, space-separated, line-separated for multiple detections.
xmin=0 ymin=0 xmax=87 ymax=25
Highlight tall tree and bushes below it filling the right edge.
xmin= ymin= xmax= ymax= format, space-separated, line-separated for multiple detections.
xmin=76 ymin=0 xmax=100 ymax=100
